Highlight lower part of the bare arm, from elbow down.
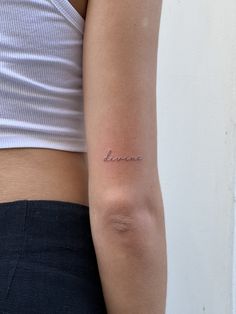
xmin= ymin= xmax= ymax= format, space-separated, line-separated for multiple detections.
xmin=91 ymin=189 xmax=167 ymax=314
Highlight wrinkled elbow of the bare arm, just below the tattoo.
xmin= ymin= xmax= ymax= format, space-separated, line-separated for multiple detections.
xmin=90 ymin=194 xmax=164 ymax=242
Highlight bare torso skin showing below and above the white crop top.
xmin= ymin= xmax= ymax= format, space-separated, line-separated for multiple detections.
xmin=0 ymin=0 xmax=88 ymax=206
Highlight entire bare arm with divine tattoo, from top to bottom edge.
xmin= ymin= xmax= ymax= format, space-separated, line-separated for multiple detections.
xmin=83 ymin=0 xmax=167 ymax=314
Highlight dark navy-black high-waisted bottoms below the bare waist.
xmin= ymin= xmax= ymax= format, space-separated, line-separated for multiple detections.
xmin=0 ymin=200 xmax=107 ymax=314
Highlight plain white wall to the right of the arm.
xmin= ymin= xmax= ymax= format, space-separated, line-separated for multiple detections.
xmin=157 ymin=0 xmax=236 ymax=314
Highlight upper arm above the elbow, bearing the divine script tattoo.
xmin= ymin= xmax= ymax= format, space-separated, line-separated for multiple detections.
xmin=83 ymin=0 xmax=161 ymax=211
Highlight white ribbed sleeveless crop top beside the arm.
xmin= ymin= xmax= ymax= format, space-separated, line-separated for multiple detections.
xmin=0 ymin=0 xmax=87 ymax=152
